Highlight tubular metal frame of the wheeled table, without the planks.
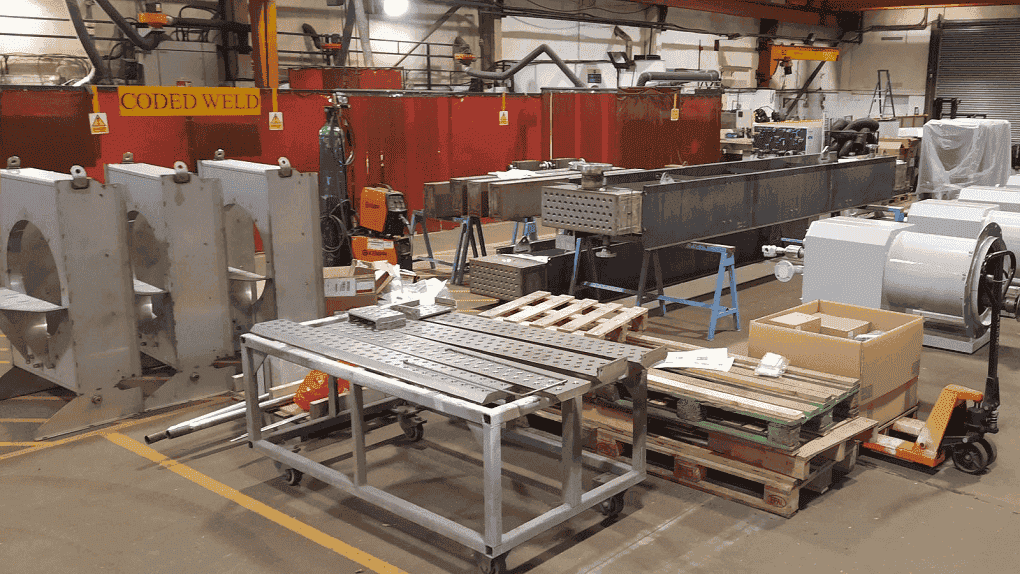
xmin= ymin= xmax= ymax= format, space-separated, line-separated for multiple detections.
xmin=241 ymin=313 xmax=644 ymax=560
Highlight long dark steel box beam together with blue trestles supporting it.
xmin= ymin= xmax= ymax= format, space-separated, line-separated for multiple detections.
xmin=542 ymin=155 xmax=896 ymax=338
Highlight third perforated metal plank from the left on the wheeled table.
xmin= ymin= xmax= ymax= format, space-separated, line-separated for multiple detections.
xmin=393 ymin=317 xmax=626 ymax=382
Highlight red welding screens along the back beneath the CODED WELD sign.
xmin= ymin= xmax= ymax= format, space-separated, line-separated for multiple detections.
xmin=0 ymin=87 xmax=721 ymax=227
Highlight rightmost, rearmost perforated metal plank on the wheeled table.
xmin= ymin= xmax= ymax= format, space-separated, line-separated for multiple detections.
xmin=427 ymin=313 xmax=666 ymax=367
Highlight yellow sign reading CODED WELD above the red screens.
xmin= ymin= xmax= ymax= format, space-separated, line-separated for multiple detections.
xmin=117 ymin=86 xmax=262 ymax=116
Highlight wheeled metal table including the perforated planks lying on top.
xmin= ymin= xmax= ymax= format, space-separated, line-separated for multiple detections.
xmin=242 ymin=308 xmax=666 ymax=572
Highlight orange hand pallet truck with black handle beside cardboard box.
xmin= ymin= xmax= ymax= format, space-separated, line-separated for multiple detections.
xmin=864 ymin=251 xmax=1017 ymax=474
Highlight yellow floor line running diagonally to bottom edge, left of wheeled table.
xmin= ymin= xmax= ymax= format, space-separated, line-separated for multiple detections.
xmin=104 ymin=432 xmax=407 ymax=574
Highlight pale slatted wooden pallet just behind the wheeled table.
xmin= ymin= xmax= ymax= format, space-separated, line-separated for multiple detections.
xmin=479 ymin=291 xmax=648 ymax=343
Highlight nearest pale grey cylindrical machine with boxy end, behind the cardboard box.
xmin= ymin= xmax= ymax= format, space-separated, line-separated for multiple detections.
xmin=765 ymin=195 xmax=1020 ymax=353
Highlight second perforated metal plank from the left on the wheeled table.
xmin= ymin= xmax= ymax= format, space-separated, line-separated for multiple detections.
xmin=321 ymin=323 xmax=591 ymax=397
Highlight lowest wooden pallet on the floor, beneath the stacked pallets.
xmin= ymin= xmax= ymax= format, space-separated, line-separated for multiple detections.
xmin=531 ymin=408 xmax=875 ymax=518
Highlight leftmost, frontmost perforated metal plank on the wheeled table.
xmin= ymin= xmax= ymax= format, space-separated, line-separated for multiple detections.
xmin=252 ymin=320 xmax=510 ymax=405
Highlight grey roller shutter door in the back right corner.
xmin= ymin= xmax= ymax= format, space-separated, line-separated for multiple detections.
xmin=935 ymin=20 xmax=1020 ymax=143
